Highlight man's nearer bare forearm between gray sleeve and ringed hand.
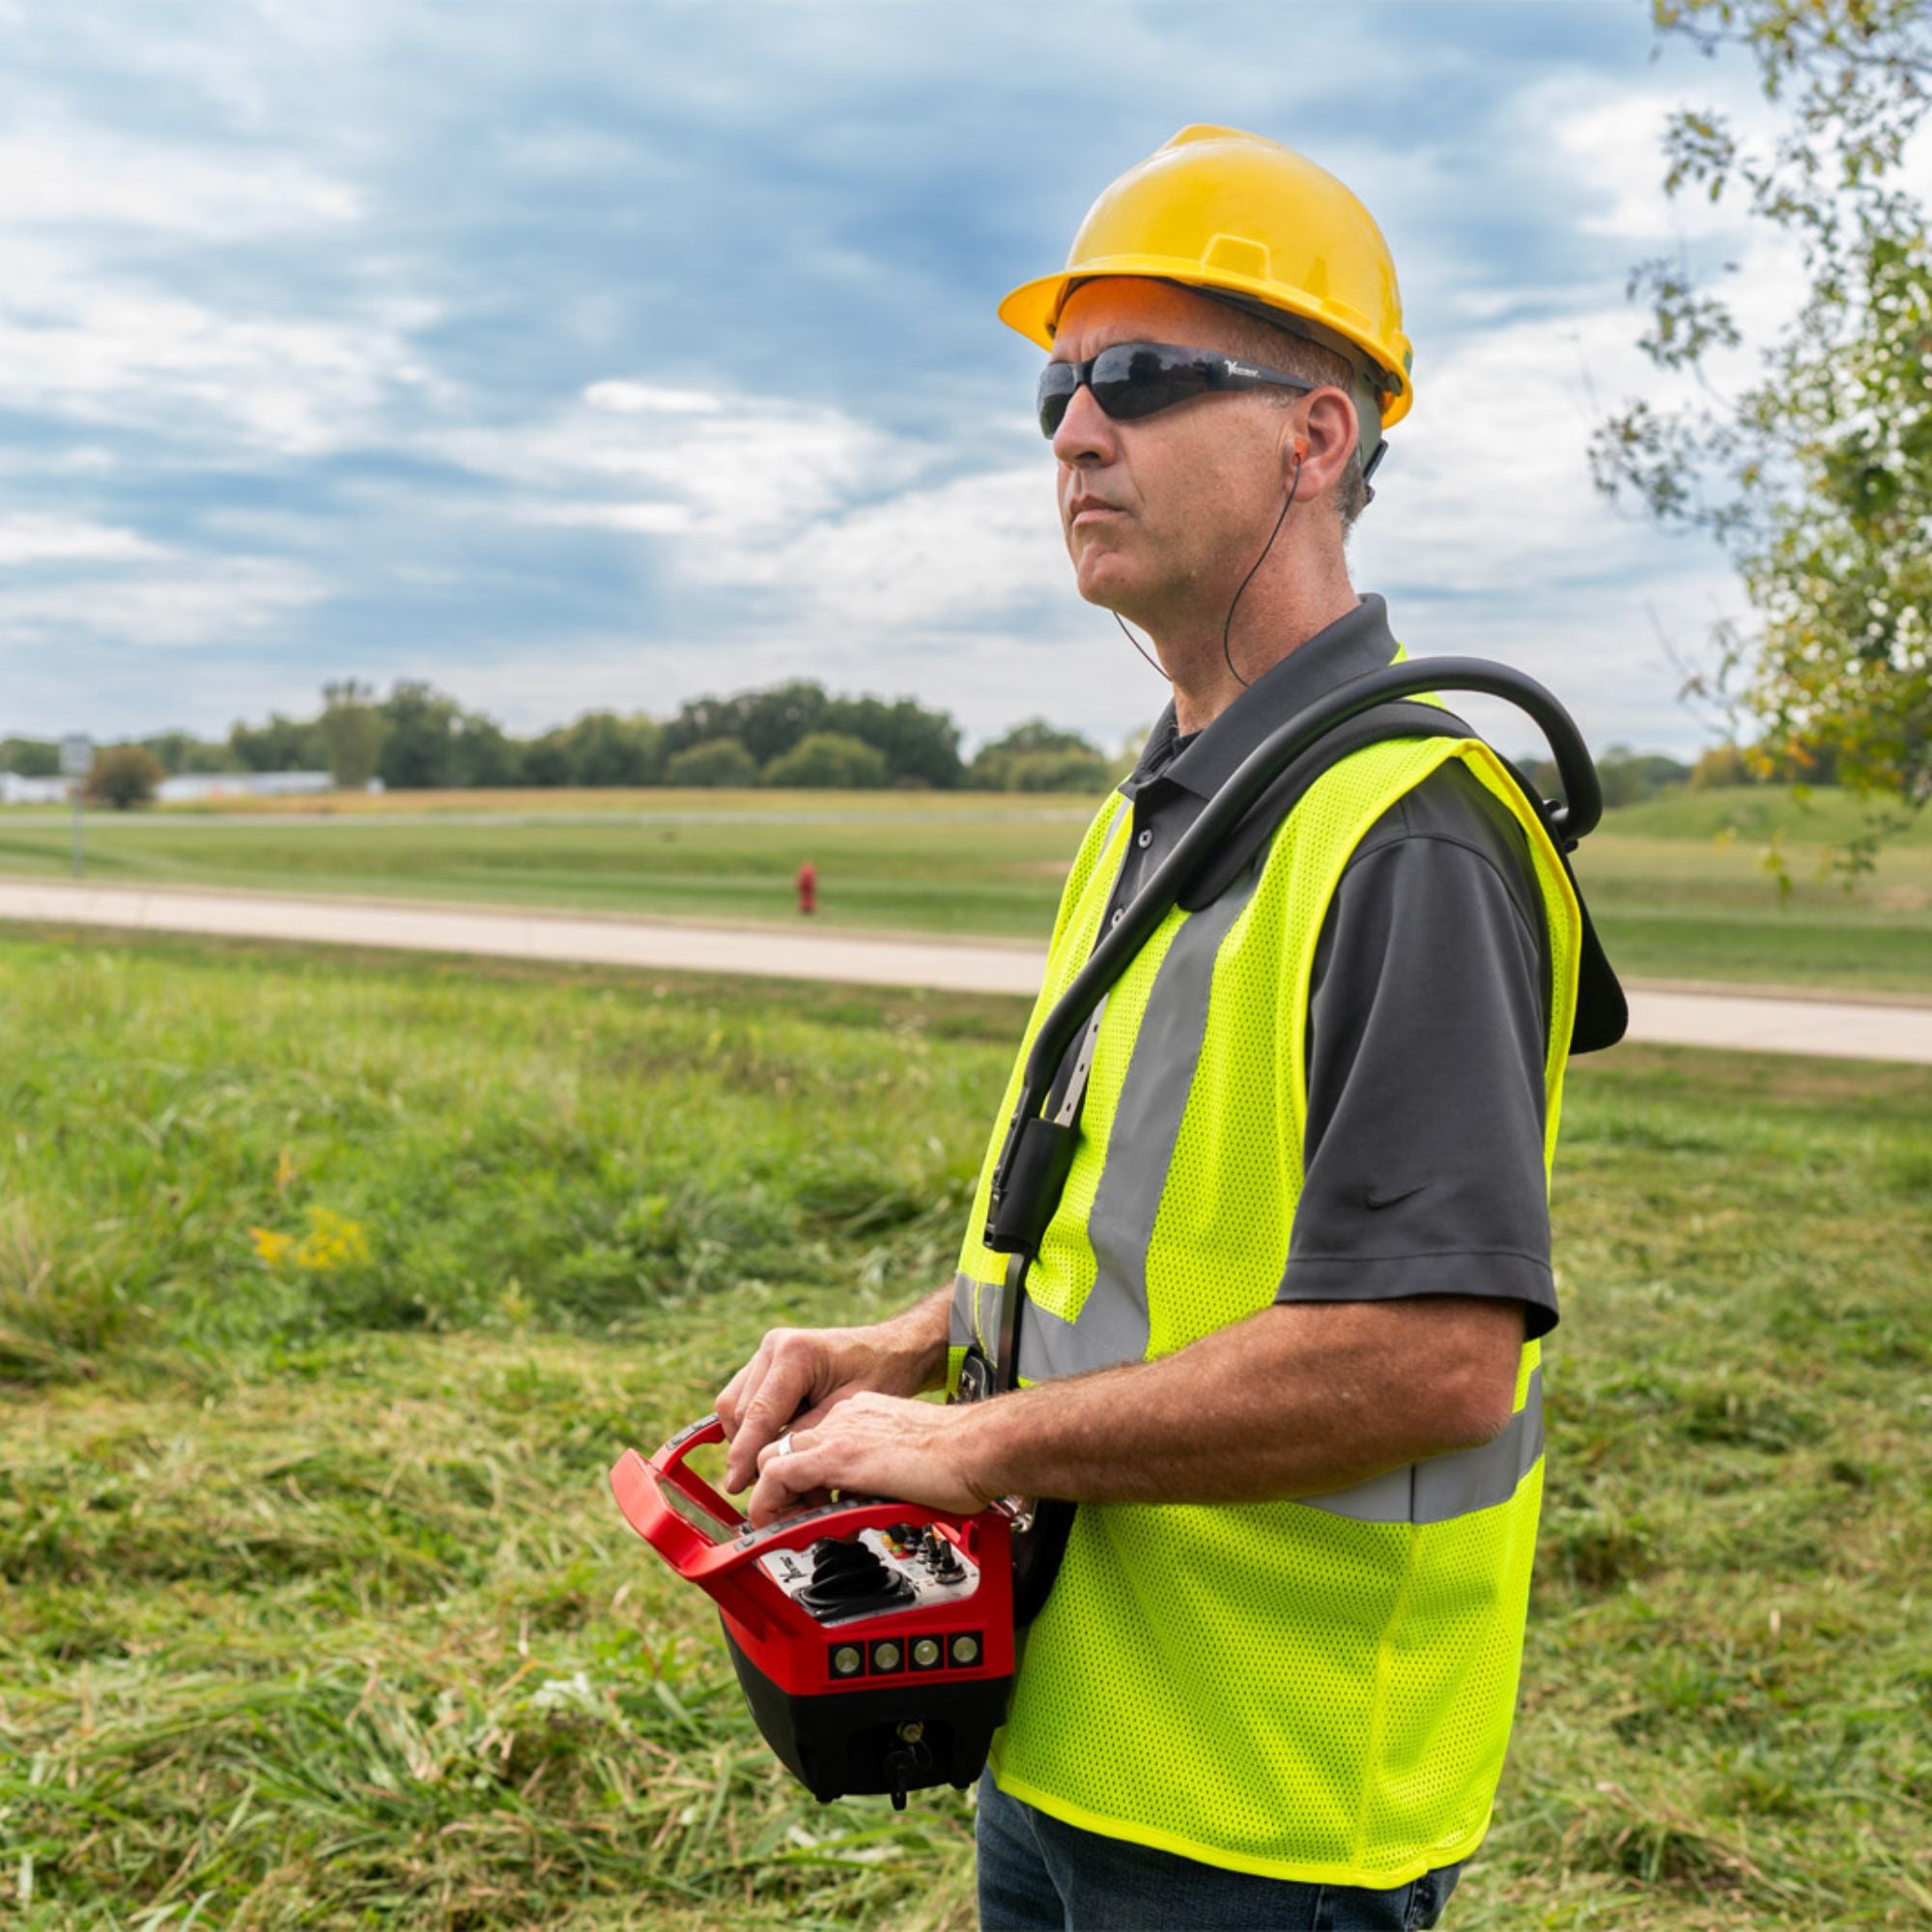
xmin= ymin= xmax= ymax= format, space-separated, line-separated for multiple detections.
xmin=958 ymin=1296 xmax=1522 ymax=1503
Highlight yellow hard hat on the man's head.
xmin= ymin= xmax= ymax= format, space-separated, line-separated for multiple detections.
xmin=999 ymin=128 xmax=1410 ymax=437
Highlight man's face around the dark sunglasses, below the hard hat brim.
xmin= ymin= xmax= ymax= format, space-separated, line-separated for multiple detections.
xmin=1053 ymin=276 xmax=1302 ymax=628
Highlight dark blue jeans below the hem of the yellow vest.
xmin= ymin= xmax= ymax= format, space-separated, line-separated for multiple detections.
xmin=978 ymin=1772 xmax=1461 ymax=1932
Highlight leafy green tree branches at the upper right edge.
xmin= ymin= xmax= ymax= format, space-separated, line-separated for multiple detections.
xmin=1590 ymin=0 xmax=1932 ymax=871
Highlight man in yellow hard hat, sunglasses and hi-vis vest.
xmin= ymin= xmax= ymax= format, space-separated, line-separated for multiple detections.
xmin=719 ymin=128 xmax=1580 ymax=1928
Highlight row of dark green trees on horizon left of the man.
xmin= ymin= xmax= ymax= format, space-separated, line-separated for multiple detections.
xmin=0 ymin=678 xmax=1109 ymax=804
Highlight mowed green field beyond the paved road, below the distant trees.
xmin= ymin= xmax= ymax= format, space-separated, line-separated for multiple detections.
xmin=0 ymin=786 xmax=1932 ymax=999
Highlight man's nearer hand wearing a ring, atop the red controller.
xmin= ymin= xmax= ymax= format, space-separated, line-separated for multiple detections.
xmin=734 ymin=1395 xmax=993 ymax=1524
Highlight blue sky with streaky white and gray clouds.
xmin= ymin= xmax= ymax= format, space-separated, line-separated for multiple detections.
xmin=0 ymin=0 xmax=1808 ymax=750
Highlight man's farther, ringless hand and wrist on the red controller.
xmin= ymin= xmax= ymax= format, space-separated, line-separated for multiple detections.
xmin=717 ymin=1289 xmax=951 ymax=1493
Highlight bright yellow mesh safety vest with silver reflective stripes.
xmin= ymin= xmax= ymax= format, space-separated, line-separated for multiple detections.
xmin=951 ymin=738 xmax=1582 ymax=1888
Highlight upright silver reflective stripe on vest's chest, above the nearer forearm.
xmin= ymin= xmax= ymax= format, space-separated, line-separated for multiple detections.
xmin=1020 ymin=848 xmax=1267 ymax=1381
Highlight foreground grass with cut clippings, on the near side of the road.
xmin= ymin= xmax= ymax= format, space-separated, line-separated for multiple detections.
xmin=0 ymin=933 xmax=1932 ymax=1932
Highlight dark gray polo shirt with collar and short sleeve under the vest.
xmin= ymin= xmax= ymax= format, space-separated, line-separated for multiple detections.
xmin=1113 ymin=593 xmax=1557 ymax=1337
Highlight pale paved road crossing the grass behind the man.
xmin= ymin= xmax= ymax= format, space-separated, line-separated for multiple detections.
xmin=0 ymin=881 xmax=1932 ymax=1066
